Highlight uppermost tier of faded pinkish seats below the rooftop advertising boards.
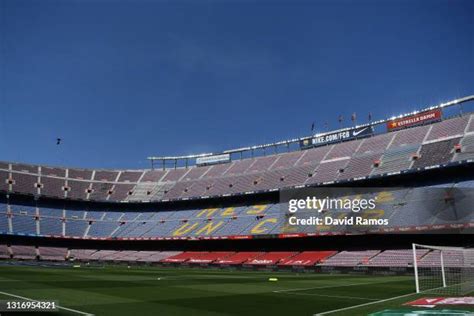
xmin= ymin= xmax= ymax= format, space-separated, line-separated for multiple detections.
xmin=0 ymin=114 xmax=474 ymax=202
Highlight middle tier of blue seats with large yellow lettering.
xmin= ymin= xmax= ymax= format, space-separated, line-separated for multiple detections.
xmin=0 ymin=177 xmax=474 ymax=238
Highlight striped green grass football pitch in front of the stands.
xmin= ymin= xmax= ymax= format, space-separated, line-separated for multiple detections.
xmin=0 ymin=266 xmax=467 ymax=316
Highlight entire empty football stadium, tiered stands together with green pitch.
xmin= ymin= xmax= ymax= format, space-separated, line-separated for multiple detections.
xmin=0 ymin=96 xmax=474 ymax=315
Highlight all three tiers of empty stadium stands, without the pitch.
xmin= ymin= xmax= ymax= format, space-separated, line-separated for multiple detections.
xmin=0 ymin=99 xmax=474 ymax=276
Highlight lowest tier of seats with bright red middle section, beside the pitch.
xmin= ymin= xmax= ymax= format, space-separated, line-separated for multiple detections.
xmin=0 ymin=244 xmax=465 ymax=268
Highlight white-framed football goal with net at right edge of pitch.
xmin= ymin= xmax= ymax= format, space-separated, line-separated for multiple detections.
xmin=413 ymin=244 xmax=474 ymax=295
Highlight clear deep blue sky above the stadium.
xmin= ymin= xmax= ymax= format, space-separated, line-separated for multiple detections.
xmin=0 ymin=0 xmax=474 ymax=168
